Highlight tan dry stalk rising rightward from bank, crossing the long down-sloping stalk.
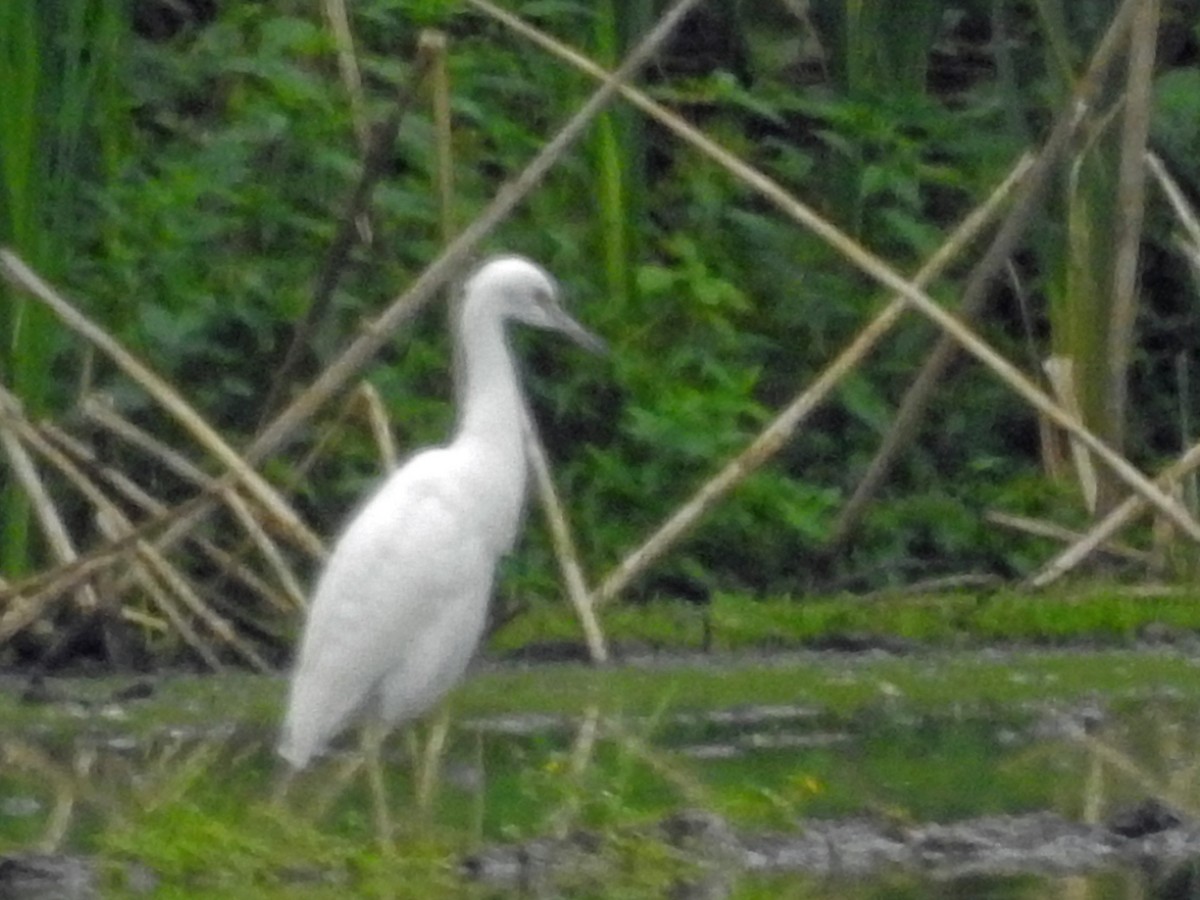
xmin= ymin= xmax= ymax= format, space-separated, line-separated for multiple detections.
xmin=595 ymin=156 xmax=1032 ymax=604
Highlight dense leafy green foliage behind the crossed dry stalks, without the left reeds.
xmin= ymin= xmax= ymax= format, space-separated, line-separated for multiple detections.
xmin=0 ymin=0 xmax=1200 ymax=657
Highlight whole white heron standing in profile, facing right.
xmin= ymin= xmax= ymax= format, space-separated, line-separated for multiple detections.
xmin=278 ymin=256 xmax=604 ymax=769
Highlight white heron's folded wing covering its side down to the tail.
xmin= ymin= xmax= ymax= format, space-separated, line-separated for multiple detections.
xmin=281 ymin=449 xmax=494 ymax=766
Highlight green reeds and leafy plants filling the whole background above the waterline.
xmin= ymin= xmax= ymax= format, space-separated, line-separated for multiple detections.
xmin=0 ymin=0 xmax=1200 ymax=664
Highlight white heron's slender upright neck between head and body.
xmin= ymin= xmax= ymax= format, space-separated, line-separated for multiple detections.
xmin=455 ymin=296 xmax=524 ymax=458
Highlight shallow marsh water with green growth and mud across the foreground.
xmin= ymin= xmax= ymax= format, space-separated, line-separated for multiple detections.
xmin=0 ymin=660 xmax=1200 ymax=899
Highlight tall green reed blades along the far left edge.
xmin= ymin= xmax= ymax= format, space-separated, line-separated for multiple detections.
xmin=0 ymin=0 xmax=128 ymax=576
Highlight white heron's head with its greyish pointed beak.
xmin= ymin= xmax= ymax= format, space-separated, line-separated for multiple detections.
xmin=464 ymin=256 xmax=605 ymax=352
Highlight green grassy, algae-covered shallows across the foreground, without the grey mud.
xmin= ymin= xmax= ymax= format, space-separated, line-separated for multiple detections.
xmin=7 ymin=650 xmax=1200 ymax=898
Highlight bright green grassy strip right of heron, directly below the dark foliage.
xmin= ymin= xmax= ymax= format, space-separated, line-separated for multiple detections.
xmin=491 ymin=584 xmax=1200 ymax=654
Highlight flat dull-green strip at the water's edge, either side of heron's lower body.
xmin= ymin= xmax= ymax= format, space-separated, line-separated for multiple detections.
xmin=0 ymin=648 xmax=1200 ymax=739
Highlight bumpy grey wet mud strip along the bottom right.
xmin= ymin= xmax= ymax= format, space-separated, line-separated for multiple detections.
xmin=463 ymin=800 xmax=1200 ymax=894
